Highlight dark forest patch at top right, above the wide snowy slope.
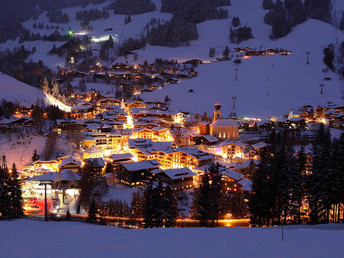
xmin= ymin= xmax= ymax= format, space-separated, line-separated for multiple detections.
xmin=262 ymin=0 xmax=332 ymax=39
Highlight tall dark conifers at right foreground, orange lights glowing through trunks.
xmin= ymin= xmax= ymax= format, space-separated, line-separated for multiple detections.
xmin=250 ymin=125 xmax=344 ymax=226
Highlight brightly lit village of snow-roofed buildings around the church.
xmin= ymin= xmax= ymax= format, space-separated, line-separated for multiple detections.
xmin=0 ymin=80 xmax=344 ymax=220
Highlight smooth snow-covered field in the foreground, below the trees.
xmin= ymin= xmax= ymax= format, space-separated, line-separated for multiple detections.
xmin=0 ymin=219 xmax=344 ymax=257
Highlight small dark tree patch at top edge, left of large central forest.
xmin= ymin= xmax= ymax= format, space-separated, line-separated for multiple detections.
xmin=108 ymin=0 xmax=156 ymax=15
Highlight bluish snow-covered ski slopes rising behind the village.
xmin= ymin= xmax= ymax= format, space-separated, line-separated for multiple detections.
xmin=0 ymin=0 xmax=344 ymax=117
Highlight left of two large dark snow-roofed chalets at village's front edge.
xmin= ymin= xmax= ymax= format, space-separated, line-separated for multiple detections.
xmin=116 ymin=160 xmax=160 ymax=187
